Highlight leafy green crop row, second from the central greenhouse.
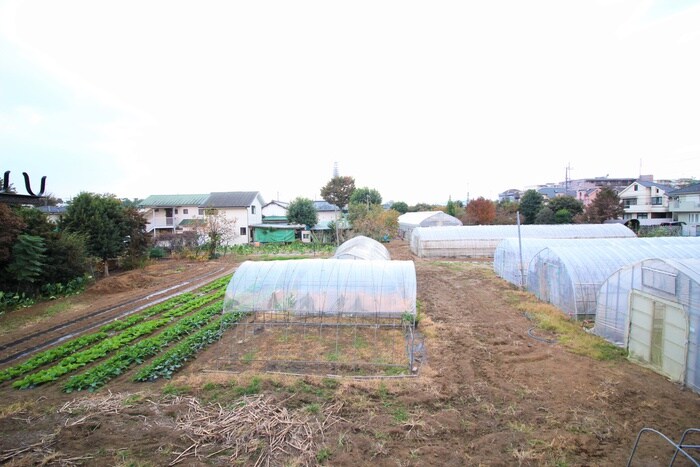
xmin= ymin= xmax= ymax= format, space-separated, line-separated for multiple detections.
xmin=63 ymin=301 xmax=223 ymax=392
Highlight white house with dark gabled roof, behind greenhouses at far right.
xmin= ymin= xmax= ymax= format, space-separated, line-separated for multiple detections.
xmin=619 ymin=176 xmax=673 ymax=221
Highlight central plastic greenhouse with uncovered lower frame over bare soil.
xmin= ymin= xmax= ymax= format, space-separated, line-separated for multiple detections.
xmin=224 ymin=258 xmax=416 ymax=375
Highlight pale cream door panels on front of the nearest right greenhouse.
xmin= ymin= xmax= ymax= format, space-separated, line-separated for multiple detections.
xmin=628 ymin=291 xmax=688 ymax=382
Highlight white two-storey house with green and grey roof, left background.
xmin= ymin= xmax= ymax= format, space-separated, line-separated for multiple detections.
xmin=139 ymin=191 xmax=264 ymax=245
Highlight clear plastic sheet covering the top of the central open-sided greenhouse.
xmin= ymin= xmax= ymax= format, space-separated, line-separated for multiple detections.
xmin=224 ymin=259 xmax=416 ymax=317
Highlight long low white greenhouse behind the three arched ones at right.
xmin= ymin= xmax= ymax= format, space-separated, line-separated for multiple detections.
xmin=411 ymin=224 xmax=635 ymax=258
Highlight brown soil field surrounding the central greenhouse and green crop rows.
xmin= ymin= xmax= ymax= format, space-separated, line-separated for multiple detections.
xmin=0 ymin=241 xmax=700 ymax=466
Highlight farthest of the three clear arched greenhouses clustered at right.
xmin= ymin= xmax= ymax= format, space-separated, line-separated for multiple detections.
xmin=493 ymin=237 xmax=697 ymax=287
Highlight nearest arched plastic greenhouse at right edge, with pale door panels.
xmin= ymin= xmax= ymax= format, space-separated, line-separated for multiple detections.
xmin=593 ymin=258 xmax=700 ymax=392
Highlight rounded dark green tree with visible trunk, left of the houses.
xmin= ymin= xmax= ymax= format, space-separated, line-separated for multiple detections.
xmin=61 ymin=192 xmax=131 ymax=276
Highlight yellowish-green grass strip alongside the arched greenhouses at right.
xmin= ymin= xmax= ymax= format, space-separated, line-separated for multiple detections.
xmin=507 ymin=291 xmax=627 ymax=361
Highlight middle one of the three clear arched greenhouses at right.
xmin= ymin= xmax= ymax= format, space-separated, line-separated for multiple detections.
xmin=527 ymin=241 xmax=700 ymax=317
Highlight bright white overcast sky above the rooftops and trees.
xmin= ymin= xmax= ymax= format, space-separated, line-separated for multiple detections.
xmin=0 ymin=0 xmax=700 ymax=205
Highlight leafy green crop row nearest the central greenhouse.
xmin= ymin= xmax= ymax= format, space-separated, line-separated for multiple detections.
xmin=133 ymin=313 xmax=241 ymax=381
